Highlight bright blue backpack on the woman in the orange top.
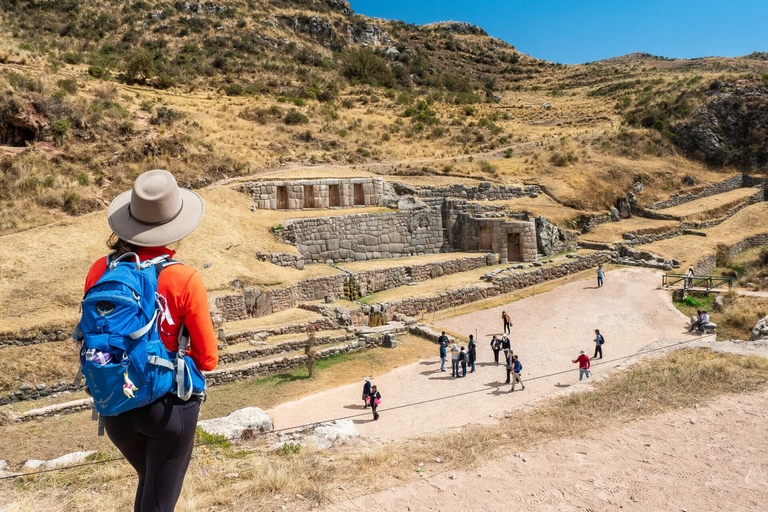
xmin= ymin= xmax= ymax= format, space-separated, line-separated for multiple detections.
xmin=72 ymin=253 xmax=205 ymax=416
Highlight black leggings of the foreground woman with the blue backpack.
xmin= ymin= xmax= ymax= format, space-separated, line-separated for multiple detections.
xmin=102 ymin=394 xmax=200 ymax=512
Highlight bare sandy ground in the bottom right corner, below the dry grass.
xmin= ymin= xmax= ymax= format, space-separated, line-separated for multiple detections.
xmin=327 ymin=392 xmax=768 ymax=512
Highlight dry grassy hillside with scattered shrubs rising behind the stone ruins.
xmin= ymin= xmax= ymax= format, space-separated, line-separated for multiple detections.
xmin=0 ymin=0 xmax=768 ymax=234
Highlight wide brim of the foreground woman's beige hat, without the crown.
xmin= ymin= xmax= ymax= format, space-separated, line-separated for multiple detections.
xmin=107 ymin=188 xmax=205 ymax=247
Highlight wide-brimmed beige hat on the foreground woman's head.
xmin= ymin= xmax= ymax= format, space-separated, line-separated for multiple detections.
xmin=107 ymin=169 xmax=205 ymax=247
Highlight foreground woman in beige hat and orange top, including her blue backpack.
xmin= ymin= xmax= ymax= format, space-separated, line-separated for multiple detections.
xmin=80 ymin=170 xmax=218 ymax=511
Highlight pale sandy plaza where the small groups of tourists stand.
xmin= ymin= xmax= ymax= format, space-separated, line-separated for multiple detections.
xmin=269 ymin=268 xmax=697 ymax=439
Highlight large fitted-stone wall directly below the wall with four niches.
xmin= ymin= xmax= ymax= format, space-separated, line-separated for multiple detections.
xmin=282 ymin=208 xmax=443 ymax=263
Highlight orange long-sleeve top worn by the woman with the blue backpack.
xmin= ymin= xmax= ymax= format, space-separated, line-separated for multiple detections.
xmin=85 ymin=247 xmax=219 ymax=371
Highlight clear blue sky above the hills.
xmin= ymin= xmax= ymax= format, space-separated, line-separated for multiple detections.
xmin=350 ymin=0 xmax=768 ymax=64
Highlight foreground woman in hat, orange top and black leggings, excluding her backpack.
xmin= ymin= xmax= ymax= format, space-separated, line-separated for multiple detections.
xmin=85 ymin=170 xmax=219 ymax=511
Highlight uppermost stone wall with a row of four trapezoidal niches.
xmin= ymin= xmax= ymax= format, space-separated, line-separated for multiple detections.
xmin=242 ymin=178 xmax=384 ymax=210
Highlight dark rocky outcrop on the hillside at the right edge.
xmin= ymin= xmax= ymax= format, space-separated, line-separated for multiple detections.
xmin=672 ymin=82 xmax=768 ymax=169
